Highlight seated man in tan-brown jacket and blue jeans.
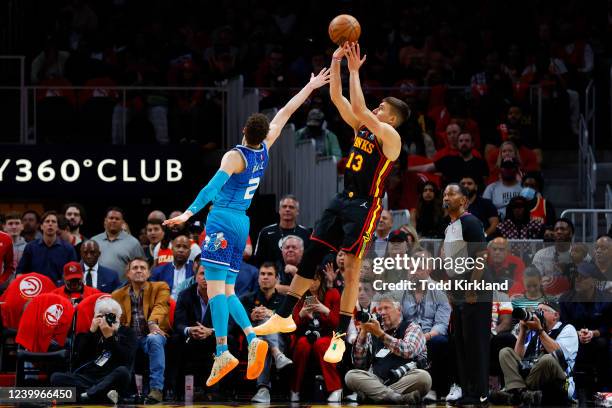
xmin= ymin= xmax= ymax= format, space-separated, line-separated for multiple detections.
xmin=112 ymin=257 xmax=170 ymax=404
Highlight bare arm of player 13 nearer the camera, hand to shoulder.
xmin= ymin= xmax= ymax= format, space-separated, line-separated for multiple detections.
xmin=344 ymin=43 xmax=402 ymax=160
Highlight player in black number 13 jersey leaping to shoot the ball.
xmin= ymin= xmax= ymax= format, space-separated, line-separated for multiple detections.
xmin=255 ymin=43 xmax=410 ymax=363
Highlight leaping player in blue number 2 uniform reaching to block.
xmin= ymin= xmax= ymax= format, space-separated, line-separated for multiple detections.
xmin=164 ymin=68 xmax=330 ymax=387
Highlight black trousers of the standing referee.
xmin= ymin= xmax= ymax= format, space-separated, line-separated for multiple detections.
xmin=452 ymin=301 xmax=491 ymax=397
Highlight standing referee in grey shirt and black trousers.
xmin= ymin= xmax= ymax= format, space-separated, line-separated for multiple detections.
xmin=443 ymin=183 xmax=491 ymax=406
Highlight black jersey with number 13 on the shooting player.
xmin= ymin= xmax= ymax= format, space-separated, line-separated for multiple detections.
xmin=344 ymin=126 xmax=393 ymax=198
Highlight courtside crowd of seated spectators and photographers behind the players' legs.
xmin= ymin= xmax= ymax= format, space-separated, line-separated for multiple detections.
xmin=0 ymin=190 xmax=612 ymax=404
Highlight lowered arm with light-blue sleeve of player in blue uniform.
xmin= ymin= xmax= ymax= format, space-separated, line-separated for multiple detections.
xmin=163 ymin=150 xmax=245 ymax=226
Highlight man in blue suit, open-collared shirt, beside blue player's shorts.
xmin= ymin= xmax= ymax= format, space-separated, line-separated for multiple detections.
xmin=151 ymin=235 xmax=193 ymax=299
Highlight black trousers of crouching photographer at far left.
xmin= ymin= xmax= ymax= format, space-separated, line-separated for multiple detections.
xmin=51 ymin=366 xmax=131 ymax=399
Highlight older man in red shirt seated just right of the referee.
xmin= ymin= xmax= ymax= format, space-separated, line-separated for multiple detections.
xmin=487 ymin=237 xmax=525 ymax=297
